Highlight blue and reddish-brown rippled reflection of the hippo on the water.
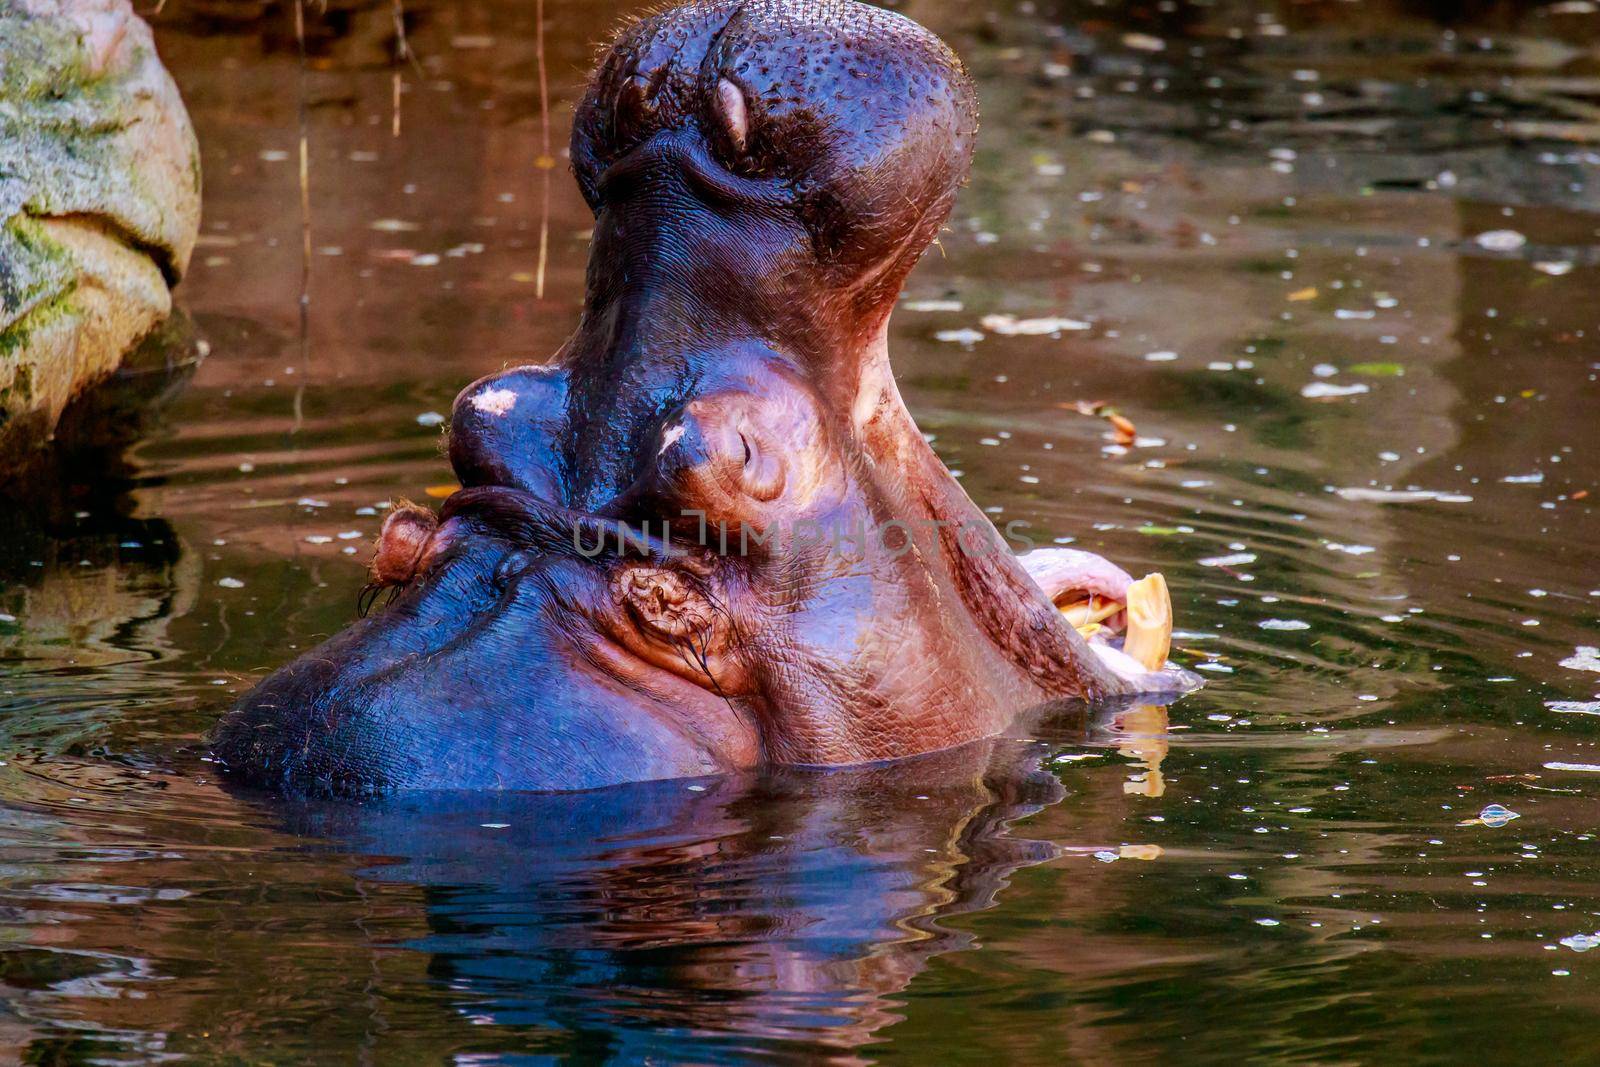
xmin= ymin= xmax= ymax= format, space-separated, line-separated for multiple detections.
xmin=286 ymin=729 xmax=1088 ymax=1064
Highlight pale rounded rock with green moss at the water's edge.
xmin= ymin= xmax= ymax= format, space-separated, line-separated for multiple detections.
xmin=0 ymin=0 xmax=200 ymax=480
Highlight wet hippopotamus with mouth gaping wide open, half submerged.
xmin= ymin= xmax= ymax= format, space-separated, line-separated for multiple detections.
xmin=213 ymin=0 xmax=1195 ymax=795
